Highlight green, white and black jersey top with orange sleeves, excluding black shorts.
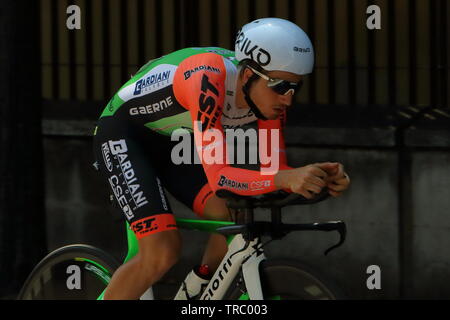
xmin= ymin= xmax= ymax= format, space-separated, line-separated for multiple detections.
xmin=102 ymin=48 xmax=286 ymax=195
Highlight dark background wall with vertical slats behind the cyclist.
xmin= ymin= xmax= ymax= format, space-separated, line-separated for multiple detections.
xmin=0 ymin=0 xmax=450 ymax=299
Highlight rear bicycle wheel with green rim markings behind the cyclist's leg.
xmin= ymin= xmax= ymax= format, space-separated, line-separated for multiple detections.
xmin=17 ymin=245 xmax=119 ymax=300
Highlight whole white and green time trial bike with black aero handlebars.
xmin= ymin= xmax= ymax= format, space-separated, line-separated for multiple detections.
xmin=18 ymin=189 xmax=346 ymax=300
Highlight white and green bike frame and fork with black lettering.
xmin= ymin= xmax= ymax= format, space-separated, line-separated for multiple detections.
xmin=98 ymin=218 xmax=266 ymax=300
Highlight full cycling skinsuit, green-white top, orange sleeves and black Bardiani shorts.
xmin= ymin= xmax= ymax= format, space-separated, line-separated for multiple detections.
xmin=94 ymin=47 xmax=288 ymax=238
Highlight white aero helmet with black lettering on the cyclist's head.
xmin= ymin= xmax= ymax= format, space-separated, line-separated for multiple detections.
xmin=235 ymin=18 xmax=314 ymax=75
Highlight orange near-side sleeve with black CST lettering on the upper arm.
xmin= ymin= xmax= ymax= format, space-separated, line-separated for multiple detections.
xmin=173 ymin=53 xmax=276 ymax=195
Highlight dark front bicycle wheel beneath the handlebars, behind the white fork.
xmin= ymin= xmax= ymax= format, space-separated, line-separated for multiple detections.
xmin=225 ymin=260 xmax=345 ymax=300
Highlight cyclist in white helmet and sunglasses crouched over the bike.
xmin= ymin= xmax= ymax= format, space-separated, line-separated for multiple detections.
xmin=94 ymin=18 xmax=350 ymax=299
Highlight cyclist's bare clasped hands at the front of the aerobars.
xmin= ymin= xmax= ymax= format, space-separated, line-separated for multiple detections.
xmin=275 ymin=164 xmax=328 ymax=199
